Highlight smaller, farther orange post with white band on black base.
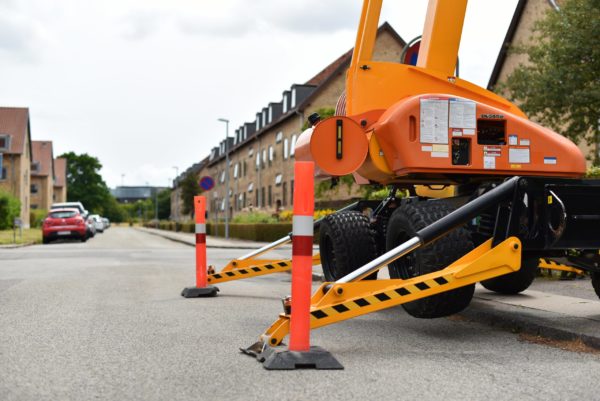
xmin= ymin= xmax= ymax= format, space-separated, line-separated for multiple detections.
xmin=181 ymin=196 xmax=219 ymax=298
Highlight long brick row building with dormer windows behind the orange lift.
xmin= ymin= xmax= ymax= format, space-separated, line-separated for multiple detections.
xmin=171 ymin=23 xmax=405 ymax=220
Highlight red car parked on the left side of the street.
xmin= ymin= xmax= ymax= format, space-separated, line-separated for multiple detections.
xmin=42 ymin=209 xmax=88 ymax=244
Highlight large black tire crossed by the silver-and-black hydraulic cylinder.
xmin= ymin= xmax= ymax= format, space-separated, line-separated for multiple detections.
xmin=386 ymin=201 xmax=475 ymax=319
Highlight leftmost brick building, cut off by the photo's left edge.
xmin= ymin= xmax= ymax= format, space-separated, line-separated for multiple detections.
xmin=0 ymin=107 xmax=31 ymax=228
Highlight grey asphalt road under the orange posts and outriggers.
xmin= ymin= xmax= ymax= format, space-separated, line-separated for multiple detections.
xmin=0 ymin=227 xmax=600 ymax=400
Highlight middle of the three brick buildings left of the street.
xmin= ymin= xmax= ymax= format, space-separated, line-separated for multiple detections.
xmin=30 ymin=141 xmax=54 ymax=210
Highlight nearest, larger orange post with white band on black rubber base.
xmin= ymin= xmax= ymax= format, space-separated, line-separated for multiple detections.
xmin=263 ymin=162 xmax=343 ymax=370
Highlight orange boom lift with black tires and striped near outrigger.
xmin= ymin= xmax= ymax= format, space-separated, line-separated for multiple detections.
xmin=245 ymin=0 xmax=600 ymax=355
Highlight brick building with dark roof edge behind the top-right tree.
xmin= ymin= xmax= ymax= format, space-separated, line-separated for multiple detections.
xmin=488 ymin=0 xmax=599 ymax=165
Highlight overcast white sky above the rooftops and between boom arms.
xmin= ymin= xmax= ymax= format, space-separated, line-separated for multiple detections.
xmin=0 ymin=0 xmax=517 ymax=187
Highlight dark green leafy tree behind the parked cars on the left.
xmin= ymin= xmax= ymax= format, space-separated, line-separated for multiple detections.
xmin=59 ymin=152 xmax=112 ymax=212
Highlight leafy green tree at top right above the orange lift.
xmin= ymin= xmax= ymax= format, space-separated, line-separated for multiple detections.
xmin=498 ymin=0 xmax=600 ymax=158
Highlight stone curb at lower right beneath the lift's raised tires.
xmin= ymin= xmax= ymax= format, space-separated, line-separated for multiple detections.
xmin=458 ymin=297 xmax=600 ymax=350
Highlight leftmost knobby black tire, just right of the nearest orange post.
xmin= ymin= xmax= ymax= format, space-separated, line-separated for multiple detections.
xmin=319 ymin=211 xmax=377 ymax=281
